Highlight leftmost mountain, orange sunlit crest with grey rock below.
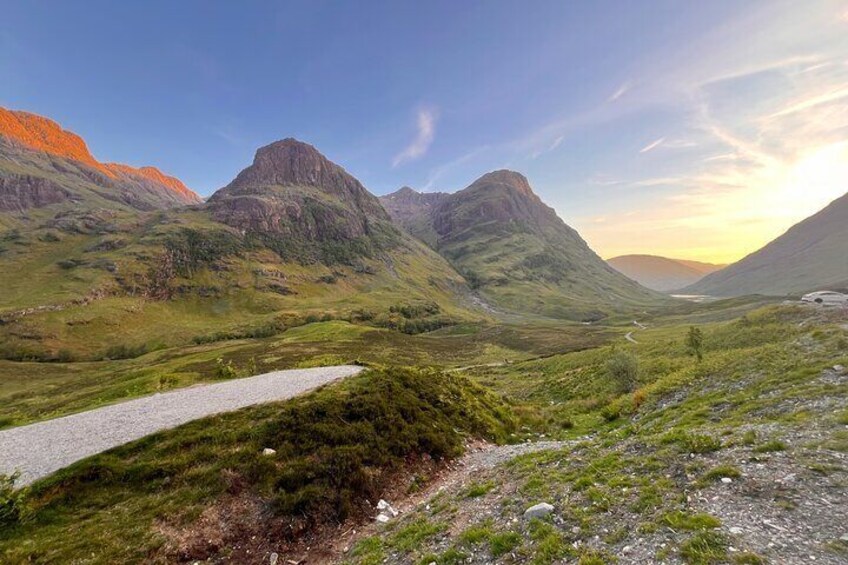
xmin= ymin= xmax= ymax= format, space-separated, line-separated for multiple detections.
xmin=0 ymin=108 xmax=201 ymax=215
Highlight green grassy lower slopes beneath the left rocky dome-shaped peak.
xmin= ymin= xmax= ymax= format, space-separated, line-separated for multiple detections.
xmin=0 ymin=205 xmax=484 ymax=360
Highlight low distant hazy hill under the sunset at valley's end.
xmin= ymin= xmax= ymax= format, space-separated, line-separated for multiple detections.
xmin=607 ymin=255 xmax=724 ymax=292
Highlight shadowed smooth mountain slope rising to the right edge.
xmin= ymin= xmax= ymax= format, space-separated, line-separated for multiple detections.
xmin=684 ymin=189 xmax=848 ymax=296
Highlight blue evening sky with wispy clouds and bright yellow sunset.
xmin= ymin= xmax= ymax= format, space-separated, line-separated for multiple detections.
xmin=0 ymin=0 xmax=848 ymax=263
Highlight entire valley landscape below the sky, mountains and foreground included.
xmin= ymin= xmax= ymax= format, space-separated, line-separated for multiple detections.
xmin=0 ymin=97 xmax=848 ymax=565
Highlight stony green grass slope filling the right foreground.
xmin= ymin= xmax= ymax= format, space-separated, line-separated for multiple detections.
xmin=346 ymin=308 xmax=848 ymax=565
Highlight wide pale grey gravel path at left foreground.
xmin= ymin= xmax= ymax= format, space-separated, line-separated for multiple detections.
xmin=0 ymin=365 xmax=362 ymax=486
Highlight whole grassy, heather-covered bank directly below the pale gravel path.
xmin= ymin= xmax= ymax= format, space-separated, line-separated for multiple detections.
xmin=0 ymin=369 xmax=514 ymax=562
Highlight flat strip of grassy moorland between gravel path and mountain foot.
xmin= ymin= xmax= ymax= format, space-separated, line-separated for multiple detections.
xmin=0 ymin=320 xmax=615 ymax=429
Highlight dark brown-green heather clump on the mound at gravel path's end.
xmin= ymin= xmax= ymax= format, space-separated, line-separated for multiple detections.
xmin=260 ymin=369 xmax=515 ymax=520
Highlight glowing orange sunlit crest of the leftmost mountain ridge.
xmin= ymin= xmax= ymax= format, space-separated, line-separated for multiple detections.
xmin=0 ymin=108 xmax=201 ymax=204
